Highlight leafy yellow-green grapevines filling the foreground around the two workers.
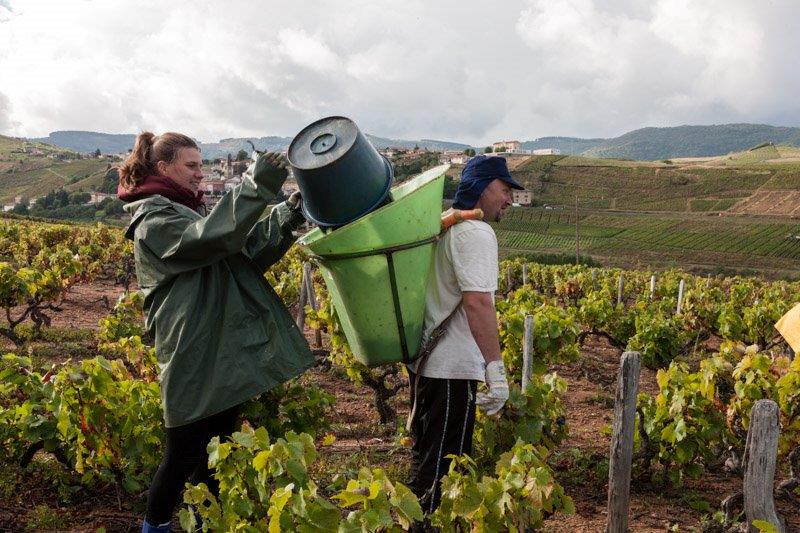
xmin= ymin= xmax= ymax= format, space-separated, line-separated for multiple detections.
xmin=0 ymin=220 xmax=800 ymax=531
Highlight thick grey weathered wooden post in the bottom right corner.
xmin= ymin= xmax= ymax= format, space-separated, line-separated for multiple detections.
xmin=744 ymin=400 xmax=786 ymax=533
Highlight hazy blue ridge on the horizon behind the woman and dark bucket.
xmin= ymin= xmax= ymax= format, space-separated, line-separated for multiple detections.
xmin=31 ymin=131 xmax=469 ymax=159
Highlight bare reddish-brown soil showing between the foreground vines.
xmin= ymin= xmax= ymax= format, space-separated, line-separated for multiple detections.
xmin=0 ymin=283 xmax=800 ymax=532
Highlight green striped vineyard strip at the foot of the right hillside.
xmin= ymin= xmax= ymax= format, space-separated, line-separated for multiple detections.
xmin=495 ymin=208 xmax=800 ymax=275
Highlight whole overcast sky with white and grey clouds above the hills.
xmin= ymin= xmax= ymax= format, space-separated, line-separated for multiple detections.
xmin=0 ymin=0 xmax=800 ymax=145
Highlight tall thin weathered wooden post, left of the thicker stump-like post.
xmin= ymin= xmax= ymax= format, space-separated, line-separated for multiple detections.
xmin=606 ymin=352 xmax=641 ymax=533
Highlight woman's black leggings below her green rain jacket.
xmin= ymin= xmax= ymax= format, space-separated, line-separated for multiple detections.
xmin=147 ymin=405 xmax=239 ymax=525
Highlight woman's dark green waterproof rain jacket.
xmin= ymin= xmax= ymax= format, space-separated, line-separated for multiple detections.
xmin=125 ymin=176 xmax=313 ymax=427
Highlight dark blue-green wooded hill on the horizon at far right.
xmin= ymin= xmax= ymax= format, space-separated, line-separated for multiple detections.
xmin=581 ymin=124 xmax=800 ymax=161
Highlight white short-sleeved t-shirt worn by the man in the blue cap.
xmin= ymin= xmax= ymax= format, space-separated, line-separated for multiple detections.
xmin=410 ymin=220 xmax=498 ymax=381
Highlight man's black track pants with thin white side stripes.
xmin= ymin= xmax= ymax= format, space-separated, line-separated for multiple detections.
xmin=409 ymin=372 xmax=478 ymax=514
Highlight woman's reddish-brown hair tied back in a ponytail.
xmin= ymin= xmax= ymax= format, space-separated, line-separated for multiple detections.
xmin=119 ymin=131 xmax=199 ymax=190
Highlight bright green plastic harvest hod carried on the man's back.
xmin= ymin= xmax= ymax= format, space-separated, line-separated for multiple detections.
xmin=299 ymin=165 xmax=449 ymax=366
